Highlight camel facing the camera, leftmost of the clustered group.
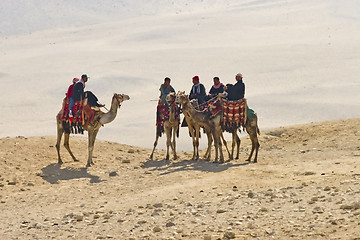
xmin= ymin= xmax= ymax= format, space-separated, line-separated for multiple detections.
xmin=150 ymin=92 xmax=180 ymax=160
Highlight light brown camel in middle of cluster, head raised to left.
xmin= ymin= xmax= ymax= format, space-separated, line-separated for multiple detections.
xmin=176 ymin=92 xmax=228 ymax=163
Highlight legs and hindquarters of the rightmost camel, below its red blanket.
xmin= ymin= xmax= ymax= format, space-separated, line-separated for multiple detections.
xmin=225 ymin=114 xmax=260 ymax=163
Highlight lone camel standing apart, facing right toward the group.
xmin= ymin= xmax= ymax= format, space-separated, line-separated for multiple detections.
xmin=56 ymin=93 xmax=130 ymax=167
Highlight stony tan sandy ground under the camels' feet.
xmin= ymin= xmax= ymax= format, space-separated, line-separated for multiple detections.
xmin=0 ymin=119 xmax=360 ymax=240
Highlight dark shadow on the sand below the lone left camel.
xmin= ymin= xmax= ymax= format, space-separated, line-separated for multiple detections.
xmin=41 ymin=163 xmax=103 ymax=184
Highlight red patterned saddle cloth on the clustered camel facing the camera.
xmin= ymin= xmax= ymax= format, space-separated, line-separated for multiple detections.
xmin=156 ymin=100 xmax=180 ymax=137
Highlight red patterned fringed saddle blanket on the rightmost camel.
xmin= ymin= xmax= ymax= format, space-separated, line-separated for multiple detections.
xmin=223 ymin=98 xmax=247 ymax=130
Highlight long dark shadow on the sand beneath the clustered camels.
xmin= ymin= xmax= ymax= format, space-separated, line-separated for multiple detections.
xmin=142 ymin=160 xmax=250 ymax=175
